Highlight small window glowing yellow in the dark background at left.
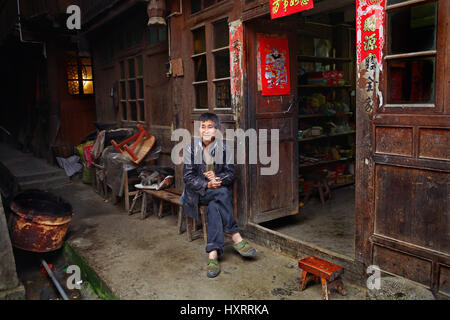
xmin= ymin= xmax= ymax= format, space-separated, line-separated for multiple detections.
xmin=66 ymin=51 xmax=94 ymax=95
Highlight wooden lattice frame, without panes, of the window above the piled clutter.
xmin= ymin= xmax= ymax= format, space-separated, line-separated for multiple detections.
xmin=118 ymin=54 xmax=147 ymax=124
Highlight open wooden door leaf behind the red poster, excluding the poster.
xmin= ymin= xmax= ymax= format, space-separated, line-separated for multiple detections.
xmin=246 ymin=19 xmax=298 ymax=223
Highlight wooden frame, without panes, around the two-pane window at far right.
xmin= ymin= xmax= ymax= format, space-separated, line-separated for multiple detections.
xmin=380 ymin=0 xmax=447 ymax=113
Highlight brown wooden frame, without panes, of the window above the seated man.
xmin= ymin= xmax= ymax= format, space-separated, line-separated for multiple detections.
xmin=190 ymin=17 xmax=232 ymax=113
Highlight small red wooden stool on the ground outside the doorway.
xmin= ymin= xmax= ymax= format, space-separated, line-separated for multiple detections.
xmin=298 ymin=257 xmax=345 ymax=300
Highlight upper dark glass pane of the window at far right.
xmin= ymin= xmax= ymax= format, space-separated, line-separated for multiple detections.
xmin=389 ymin=2 xmax=437 ymax=54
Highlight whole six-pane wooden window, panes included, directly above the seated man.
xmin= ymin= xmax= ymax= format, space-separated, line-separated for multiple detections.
xmin=192 ymin=19 xmax=231 ymax=111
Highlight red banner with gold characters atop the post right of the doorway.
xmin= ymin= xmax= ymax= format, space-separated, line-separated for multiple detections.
xmin=356 ymin=0 xmax=385 ymax=64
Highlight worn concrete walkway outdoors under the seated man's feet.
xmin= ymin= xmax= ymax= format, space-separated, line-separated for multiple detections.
xmin=52 ymin=183 xmax=365 ymax=300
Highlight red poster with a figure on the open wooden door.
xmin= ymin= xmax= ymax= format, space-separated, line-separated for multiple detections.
xmin=259 ymin=38 xmax=291 ymax=96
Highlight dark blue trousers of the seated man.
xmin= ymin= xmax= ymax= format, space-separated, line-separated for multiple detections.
xmin=200 ymin=187 xmax=238 ymax=256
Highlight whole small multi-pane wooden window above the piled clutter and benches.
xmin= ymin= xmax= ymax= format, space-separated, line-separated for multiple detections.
xmin=119 ymin=56 xmax=145 ymax=122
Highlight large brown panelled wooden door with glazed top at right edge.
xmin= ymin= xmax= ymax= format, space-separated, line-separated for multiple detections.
xmin=356 ymin=0 xmax=450 ymax=294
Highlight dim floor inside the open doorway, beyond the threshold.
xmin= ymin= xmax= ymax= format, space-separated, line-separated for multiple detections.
xmin=262 ymin=186 xmax=355 ymax=259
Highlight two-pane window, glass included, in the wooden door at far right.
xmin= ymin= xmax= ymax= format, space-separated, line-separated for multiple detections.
xmin=384 ymin=0 xmax=445 ymax=108
